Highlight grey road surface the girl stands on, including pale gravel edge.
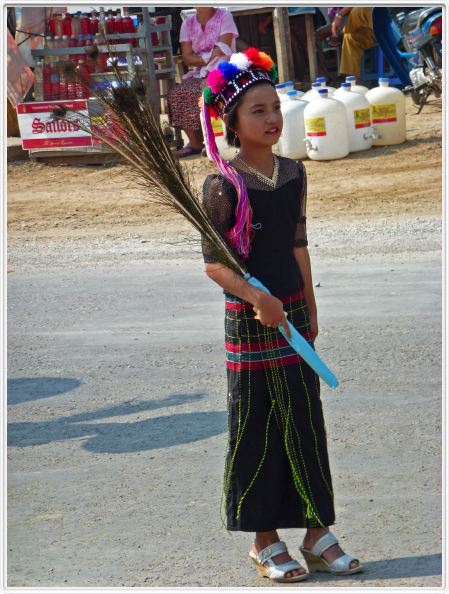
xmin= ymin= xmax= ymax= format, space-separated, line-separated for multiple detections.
xmin=8 ymin=212 xmax=442 ymax=591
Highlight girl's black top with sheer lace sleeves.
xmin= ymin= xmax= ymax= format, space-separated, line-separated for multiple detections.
xmin=203 ymin=157 xmax=307 ymax=297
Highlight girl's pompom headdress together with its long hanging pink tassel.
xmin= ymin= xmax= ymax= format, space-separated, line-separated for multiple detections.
xmin=201 ymin=47 xmax=277 ymax=258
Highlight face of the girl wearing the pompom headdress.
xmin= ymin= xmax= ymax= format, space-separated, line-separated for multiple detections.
xmin=228 ymin=84 xmax=282 ymax=147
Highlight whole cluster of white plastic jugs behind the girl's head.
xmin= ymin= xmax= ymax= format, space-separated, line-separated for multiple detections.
xmin=205 ymin=76 xmax=406 ymax=161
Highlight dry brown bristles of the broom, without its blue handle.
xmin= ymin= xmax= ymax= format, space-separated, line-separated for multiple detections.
xmin=52 ymin=46 xmax=246 ymax=276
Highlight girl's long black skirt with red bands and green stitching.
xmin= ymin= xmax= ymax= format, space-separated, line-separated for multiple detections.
xmin=224 ymin=292 xmax=335 ymax=532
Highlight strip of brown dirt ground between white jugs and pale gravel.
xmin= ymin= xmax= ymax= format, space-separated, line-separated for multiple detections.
xmin=8 ymin=101 xmax=442 ymax=240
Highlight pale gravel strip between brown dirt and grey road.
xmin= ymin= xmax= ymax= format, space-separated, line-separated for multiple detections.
xmin=8 ymin=217 xmax=442 ymax=272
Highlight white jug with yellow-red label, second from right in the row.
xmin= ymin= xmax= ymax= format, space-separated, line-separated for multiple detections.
xmin=334 ymin=83 xmax=376 ymax=153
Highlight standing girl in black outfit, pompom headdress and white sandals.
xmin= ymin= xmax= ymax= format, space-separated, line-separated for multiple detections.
xmin=203 ymin=48 xmax=362 ymax=582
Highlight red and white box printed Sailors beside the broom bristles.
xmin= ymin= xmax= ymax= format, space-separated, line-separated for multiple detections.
xmin=17 ymin=99 xmax=92 ymax=150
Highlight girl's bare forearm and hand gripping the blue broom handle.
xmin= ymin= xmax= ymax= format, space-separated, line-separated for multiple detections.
xmin=205 ymin=263 xmax=290 ymax=336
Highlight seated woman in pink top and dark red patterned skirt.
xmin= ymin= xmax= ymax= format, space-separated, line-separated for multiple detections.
xmin=168 ymin=7 xmax=238 ymax=158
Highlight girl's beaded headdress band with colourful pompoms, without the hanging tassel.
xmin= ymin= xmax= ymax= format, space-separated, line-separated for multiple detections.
xmin=203 ymin=47 xmax=277 ymax=117
